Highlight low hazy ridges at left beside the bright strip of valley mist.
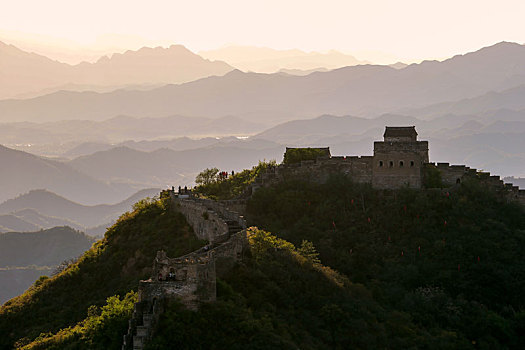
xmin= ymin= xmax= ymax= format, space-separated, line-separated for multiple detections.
xmin=0 ymin=115 xmax=267 ymax=156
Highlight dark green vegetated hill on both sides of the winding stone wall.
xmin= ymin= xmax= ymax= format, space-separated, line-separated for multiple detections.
xmin=0 ymin=165 xmax=525 ymax=349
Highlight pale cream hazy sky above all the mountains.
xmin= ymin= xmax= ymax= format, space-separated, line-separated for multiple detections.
xmin=0 ymin=0 xmax=525 ymax=60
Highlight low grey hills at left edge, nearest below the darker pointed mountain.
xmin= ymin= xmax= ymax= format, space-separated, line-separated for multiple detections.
xmin=0 ymin=188 xmax=160 ymax=235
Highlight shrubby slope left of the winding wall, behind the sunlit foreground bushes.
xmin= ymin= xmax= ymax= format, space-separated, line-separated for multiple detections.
xmin=0 ymin=200 xmax=202 ymax=349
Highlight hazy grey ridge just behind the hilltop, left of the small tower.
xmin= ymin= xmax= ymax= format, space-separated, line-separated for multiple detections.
xmin=68 ymin=141 xmax=283 ymax=187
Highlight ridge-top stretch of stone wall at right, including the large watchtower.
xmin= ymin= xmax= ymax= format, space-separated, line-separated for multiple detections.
xmin=250 ymin=126 xmax=525 ymax=205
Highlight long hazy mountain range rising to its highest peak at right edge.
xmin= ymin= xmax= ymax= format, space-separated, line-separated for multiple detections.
xmin=0 ymin=42 xmax=525 ymax=123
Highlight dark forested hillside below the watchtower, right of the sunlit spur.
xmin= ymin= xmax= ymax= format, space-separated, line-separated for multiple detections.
xmin=244 ymin=177 xmax=525 ymax=349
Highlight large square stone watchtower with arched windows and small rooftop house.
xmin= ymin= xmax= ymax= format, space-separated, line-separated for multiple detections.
xmin=372 ymin=126 xmax=428 ymax=188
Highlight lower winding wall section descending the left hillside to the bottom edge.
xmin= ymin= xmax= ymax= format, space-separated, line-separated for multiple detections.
xmin=122 ymin=191 xmax=248 ymax=350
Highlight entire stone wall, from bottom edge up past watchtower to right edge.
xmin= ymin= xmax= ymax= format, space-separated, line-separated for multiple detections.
xmin=122 ymin=127 xmax=525 ymax=350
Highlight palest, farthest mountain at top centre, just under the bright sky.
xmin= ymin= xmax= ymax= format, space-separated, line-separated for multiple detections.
xmin=199 ymin=46 xmax=369 ymax=73
